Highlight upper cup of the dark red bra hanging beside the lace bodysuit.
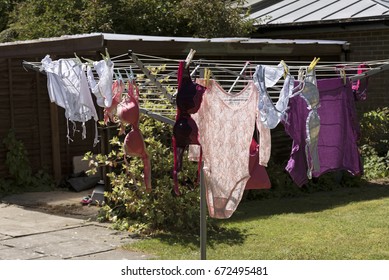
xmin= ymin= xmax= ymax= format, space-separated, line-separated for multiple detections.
xmin=176 ymin=79 xmax=205 ymax=114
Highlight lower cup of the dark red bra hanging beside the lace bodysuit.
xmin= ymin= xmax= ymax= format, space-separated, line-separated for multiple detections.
xmin=173 ymin=116 xmax=200 ymax=147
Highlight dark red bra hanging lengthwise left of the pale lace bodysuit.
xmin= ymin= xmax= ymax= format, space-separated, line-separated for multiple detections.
xmin=172 ymin=61 xmax=206 ymax=195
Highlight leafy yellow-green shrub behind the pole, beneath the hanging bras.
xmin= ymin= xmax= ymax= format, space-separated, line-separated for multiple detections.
xmin=84 ymin=115 xmax=215 ymax=234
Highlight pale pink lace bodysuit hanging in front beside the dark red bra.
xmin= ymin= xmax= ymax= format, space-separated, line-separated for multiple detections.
xmin=196 ymin=80 xmax=258 ymax=219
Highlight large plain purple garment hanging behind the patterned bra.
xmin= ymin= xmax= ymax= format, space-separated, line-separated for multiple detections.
xmin=283 ymin=78 xmax=362 ymax=187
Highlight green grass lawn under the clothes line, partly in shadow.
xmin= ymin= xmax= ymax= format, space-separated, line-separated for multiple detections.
xmin=125 ymin=180 xmax=389 ymax=260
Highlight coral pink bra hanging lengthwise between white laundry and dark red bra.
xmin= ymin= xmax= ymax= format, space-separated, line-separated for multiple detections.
xmin=117 ymin=81 xmax=151 ymax=192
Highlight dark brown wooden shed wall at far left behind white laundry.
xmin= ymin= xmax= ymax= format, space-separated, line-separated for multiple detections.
xmin=0 ymin=58 xmax=99 ymax=179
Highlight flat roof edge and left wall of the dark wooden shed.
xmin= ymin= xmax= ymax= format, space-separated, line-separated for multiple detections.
xmin=0 ymin=33 xmax=350 ymax=184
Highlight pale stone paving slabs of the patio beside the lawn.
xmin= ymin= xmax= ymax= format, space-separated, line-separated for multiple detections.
xmin=0 ymin=191 xmax=154 ymax=260
